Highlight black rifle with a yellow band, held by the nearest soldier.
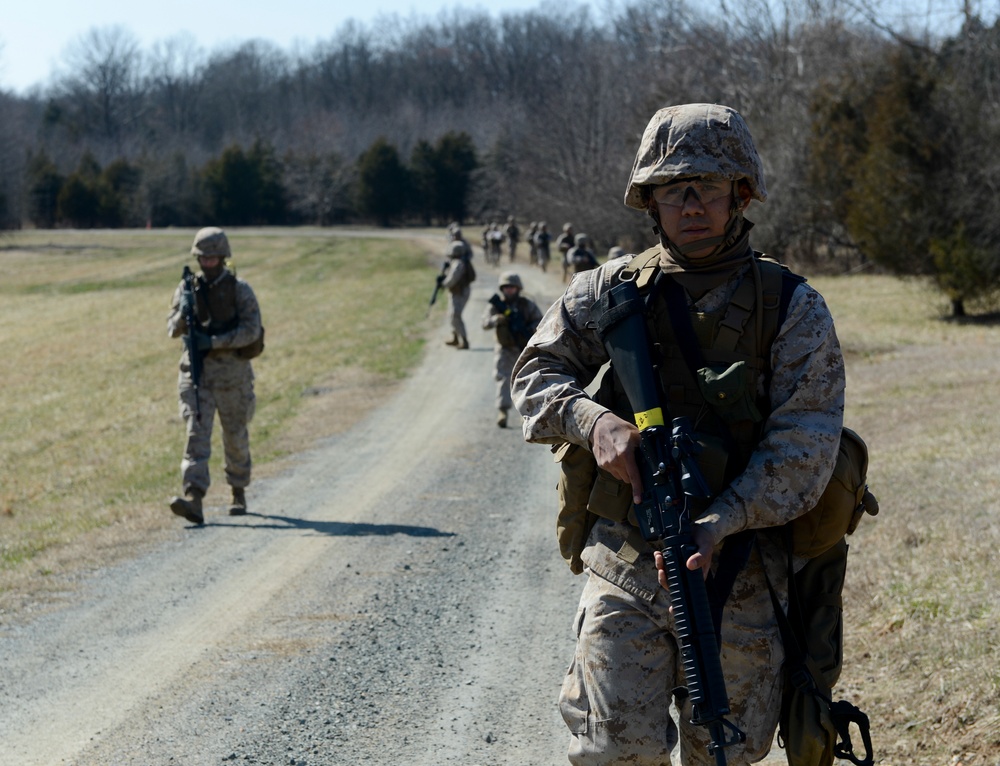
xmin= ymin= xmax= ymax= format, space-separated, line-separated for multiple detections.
xmin=597 ymin=281 xmax=746 ymax=766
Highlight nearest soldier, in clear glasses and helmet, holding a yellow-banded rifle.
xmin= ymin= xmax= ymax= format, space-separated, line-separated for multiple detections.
xmin=512 ymin=104 xmax=845 ymax=766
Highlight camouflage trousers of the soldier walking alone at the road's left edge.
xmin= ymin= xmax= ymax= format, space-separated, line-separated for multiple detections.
xmin=178 ymin=362 xmax=256 ymax=494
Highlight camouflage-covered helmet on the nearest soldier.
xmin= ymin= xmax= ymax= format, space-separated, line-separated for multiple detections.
xmin=625 ymin=104 xmax=767 ymax=210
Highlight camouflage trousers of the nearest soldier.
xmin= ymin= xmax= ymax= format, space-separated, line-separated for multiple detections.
xmin=559 ymin=551 xmax=784 ymax=766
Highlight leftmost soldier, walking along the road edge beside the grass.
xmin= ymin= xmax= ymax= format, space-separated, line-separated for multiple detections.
xmin=167 ymin=226 xmax=264 ymax=524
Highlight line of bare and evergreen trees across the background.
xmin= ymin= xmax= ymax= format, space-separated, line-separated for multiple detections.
xmin=0 ymin=0 xmax=1000 ymax=313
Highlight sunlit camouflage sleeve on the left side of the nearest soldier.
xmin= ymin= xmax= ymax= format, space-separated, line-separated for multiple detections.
xmin=511 ymin=259 xmax=628 ymax=449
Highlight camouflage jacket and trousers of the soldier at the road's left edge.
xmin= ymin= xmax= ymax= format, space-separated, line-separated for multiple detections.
xmin=167 ymin=230 xmax=261 ymax=516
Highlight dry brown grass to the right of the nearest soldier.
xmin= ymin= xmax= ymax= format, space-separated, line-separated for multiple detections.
xmin=814 ymin=277 xmax=1000 ymax=766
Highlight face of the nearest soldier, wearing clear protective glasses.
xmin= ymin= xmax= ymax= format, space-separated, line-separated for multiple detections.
xmin=652 ymin=179 xmax=749 ymax=259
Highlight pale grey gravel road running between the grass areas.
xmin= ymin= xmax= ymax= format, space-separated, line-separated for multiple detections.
xmin=0 ymin=245 xmax=583 ymax=766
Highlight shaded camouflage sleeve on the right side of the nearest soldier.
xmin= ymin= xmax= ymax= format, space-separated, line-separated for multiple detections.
xmin=698 ymin=284 xmax=845 ymax=542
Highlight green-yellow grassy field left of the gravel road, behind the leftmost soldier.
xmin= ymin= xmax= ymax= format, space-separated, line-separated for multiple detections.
xmin=0 ymin=230 xmax=443 ymax=606
